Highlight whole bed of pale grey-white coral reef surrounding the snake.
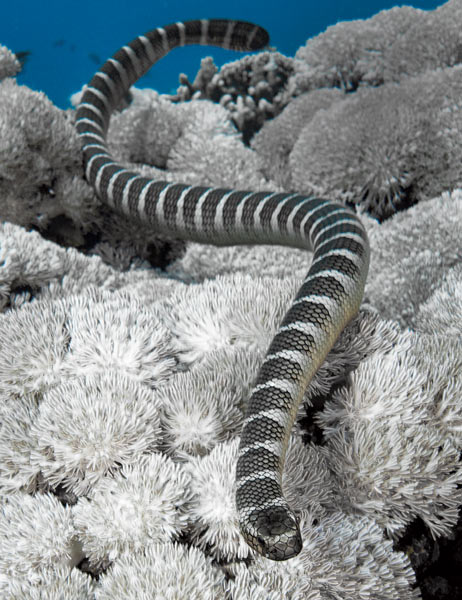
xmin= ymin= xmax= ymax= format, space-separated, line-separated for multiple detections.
xmin=0 ymin=0 xmax=462 ymax=600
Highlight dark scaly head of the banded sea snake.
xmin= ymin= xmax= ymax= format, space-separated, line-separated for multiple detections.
xmin=240 ymin=506 xmax=303 ymax=560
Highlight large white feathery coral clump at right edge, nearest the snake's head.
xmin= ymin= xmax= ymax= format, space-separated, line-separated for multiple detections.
xmin=317 ymin=333 xmax=462 ymax=537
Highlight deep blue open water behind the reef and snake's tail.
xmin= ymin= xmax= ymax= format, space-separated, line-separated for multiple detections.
xmin=0 ymin=0 xmax=443 ymax=109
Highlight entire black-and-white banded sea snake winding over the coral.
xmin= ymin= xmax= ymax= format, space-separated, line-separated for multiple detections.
xmin=76 ymin=19 xmax=369 ymax=560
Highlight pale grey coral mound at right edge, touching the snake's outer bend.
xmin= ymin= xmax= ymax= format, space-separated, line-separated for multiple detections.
xmin=366 ymin=190 xmax=462 ymax=331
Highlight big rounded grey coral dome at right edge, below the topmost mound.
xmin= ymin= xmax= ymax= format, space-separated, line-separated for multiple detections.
xmin=290 ymin=67 xmax=462 ymax=218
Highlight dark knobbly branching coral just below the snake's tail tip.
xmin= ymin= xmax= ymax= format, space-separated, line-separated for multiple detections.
xmin=172 ymin=52 xmax=294 ymax=143
